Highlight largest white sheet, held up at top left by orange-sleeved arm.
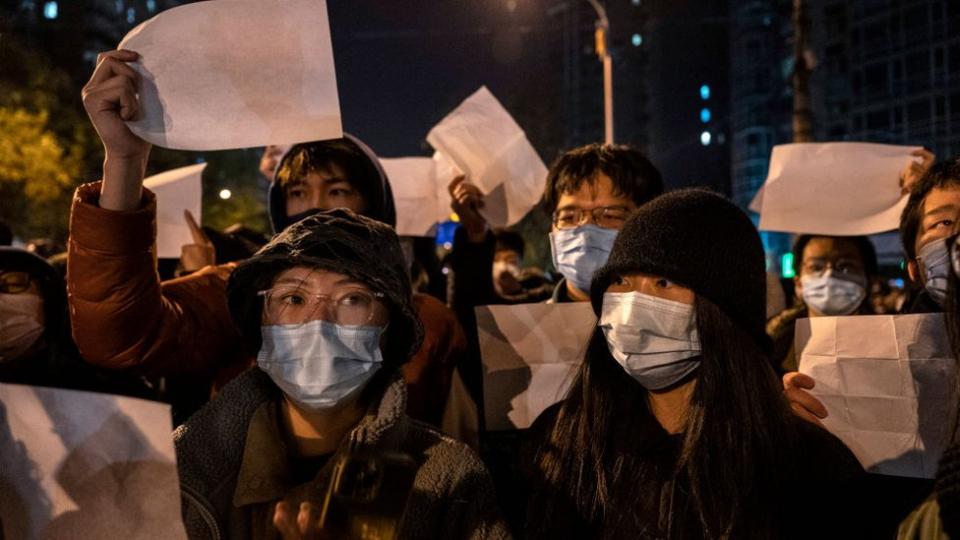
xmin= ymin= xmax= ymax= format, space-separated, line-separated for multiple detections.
xmin=119 ymin=0 xmax=343 ymax=150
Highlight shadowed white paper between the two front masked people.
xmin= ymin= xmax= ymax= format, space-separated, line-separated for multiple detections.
xmin=476 ymin=302 xmax=597 ymax=431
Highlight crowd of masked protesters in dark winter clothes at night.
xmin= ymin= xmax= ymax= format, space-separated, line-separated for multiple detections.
xmin=0 ymin=42 xmax=960 ymax=539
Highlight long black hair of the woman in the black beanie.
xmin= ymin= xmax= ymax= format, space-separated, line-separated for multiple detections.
xmin=527 ymin=296 xmax=798 ymax=538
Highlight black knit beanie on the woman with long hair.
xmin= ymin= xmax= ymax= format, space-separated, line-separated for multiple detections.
xmin=590 ymin=189 xmax=769 ymax=348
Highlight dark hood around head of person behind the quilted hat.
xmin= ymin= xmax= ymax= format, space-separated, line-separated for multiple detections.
xmin=267 ymin=133 xmax=397 ymax=234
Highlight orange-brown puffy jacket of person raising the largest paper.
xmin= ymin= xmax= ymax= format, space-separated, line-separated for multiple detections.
xmin=67 ymin=182 xmax=467 ymax=425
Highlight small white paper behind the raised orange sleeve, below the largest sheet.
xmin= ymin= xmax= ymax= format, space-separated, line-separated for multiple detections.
xmin=143 ymin=163 xmax=207 ymax=259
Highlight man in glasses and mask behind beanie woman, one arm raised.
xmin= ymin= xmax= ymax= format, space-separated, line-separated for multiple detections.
xmin=450 ymin=143 xmax=663 ymax=310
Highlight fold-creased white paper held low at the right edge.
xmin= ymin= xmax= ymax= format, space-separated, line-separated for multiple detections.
xmin=795 ymin=313 xmax=957 ymax=478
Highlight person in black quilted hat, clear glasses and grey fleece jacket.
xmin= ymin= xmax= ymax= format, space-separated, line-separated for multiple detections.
xmin=175 ymin=210 xmax=507 ymax=539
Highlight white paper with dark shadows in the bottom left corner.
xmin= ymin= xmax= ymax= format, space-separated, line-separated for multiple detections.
xmin=0 ymin=384 xmax=187 ymax=540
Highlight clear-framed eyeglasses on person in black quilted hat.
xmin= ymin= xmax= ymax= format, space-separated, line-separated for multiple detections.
xmin=257 ymin=286 xmax=385 ymax=326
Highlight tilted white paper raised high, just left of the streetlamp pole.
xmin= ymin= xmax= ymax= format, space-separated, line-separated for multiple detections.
xmin=427 ymin=86 xmax=547 ymax=227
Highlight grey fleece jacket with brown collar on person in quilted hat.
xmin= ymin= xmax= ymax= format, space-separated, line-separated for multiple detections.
xmin=174 ymin=368 xmax=510 ymax=540
